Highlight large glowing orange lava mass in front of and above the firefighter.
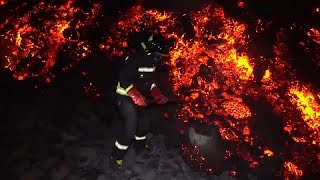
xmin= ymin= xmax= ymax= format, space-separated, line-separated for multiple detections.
xmin=104 ymin=2 xmax=320 ymax=178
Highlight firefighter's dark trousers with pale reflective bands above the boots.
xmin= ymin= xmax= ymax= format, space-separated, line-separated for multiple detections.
xmin=111 ymin=95 xmax=149 ymax=160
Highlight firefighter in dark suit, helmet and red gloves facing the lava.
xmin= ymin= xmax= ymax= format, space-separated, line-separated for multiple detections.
xmin=110 ymin=35 xmax=168 ymax=168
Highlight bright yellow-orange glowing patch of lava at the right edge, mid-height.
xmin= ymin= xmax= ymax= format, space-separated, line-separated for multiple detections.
xmin=290 ymin=87 xmax=320 ymax=132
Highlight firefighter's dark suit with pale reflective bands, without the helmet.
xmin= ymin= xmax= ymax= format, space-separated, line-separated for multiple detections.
xmin=111 ymin=54 xmax=166 ymax=165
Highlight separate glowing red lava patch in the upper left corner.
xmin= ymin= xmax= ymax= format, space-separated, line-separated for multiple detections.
xmin=0 ymin=0 xmax=101 ymax=82
